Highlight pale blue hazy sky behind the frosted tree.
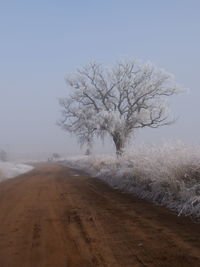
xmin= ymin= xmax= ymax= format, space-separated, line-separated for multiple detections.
xmin=0 ymin=0 xmax=200 ymax=157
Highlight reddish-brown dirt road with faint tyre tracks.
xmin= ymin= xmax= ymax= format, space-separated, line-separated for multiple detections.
xmin=0 ymin=165 xmax=200 ymax=267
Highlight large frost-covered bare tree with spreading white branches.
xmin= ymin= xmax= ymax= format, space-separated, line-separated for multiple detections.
xmin=59 ymin=60 xmax=181 ymax=155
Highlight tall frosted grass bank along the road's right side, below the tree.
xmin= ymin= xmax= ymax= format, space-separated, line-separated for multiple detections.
xmin=59 ymin=143 xmax=200 ymax=219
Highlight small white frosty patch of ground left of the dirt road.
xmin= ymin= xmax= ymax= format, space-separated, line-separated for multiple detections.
xmin=0 ymin=162 xmax=33 ymax=181
